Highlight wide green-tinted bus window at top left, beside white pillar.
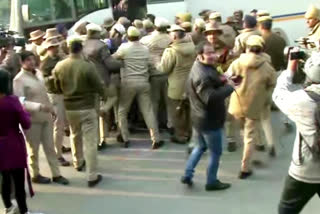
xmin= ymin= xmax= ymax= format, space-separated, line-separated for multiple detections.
xmin=22 ymin=0 xmax=73 ymax=26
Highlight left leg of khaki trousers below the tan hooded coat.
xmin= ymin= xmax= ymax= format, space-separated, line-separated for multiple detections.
xmin=241 ymin=118 xmax=260 ymax=172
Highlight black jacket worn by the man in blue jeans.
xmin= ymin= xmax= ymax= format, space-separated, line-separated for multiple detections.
xmin=187 ymin=61 xmax=234 ymax=131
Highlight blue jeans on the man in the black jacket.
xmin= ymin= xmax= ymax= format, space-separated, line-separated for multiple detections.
xmin=185 ymin=129 xmax=223 ymax=185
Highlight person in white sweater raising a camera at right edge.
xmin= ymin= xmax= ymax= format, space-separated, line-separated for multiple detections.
xmin=273 ymin=48 xmax=320 ymax=214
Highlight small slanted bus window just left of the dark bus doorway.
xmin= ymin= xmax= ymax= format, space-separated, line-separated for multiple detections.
xmin=74 ymin=0 xmax=109 ymax=18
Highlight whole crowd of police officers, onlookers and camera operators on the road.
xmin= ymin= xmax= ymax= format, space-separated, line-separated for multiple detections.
xmin=0 ymin=3 xmax=320 ymax=214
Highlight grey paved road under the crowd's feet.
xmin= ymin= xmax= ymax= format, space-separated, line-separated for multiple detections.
xmin=0 ymin=113 xmax=320 ymax=214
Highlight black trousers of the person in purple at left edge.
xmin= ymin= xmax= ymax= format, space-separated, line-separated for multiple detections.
xmin=1 ymin=169 xmax=28 ymax=214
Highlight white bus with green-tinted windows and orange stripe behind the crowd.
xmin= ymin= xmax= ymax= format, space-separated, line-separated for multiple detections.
xmin=4 ymin=0 xmax=317 ymax=45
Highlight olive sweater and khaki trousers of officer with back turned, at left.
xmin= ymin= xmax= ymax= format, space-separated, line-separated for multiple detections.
xmin=53 ymin=55 xmax=105 ymax=181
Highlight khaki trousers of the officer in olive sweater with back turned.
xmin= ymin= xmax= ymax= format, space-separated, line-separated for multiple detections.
xmin=66 ymin=109 xmax=99 ymax=181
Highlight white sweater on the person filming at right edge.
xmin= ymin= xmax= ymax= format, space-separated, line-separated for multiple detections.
xmin=273 ymin=70 xmax=320 ymax=183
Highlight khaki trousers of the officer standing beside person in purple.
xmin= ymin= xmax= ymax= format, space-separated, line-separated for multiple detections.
xmin=25 ymin=121 xmax=61 ymax=177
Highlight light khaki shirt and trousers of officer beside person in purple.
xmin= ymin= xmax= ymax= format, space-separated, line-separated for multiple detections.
xmin=13 ymin=69 xmax=60 ymax=177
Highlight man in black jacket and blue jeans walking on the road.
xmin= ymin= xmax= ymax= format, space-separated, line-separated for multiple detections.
xmin=181 ymin=42 xmax=234 ymax=191
